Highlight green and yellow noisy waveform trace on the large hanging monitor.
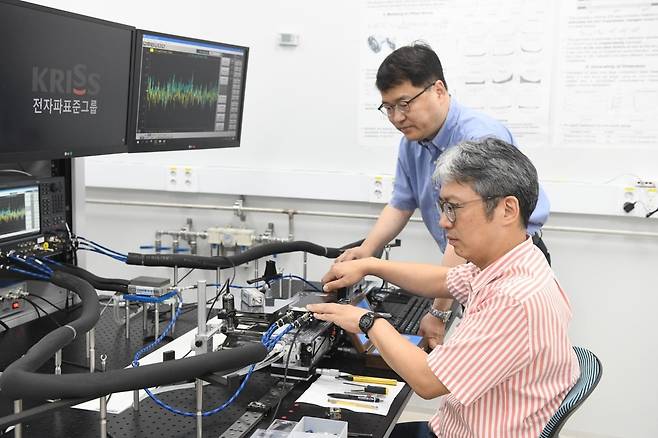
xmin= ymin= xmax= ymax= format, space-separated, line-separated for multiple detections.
xmin=146 ymin=76 xmax=217 ymax=109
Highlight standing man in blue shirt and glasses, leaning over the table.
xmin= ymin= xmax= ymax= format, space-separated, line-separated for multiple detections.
xmin=336 ymin=43 xmax=550 ymax=348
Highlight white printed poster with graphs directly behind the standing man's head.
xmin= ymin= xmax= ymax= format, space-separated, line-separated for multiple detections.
xmin=358 ymin=0 xmax=556 ymax=147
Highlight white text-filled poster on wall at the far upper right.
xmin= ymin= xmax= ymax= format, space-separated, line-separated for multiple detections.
xmin=555 ymin=0 xmax=658 ymax=148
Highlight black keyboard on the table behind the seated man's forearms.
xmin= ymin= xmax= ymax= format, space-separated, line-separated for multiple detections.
xmin=376 ymin=292 xmax=432 ymax=335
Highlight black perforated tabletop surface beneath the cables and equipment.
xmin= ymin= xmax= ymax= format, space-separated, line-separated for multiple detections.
xmin=0 ymin=302 xmax=411 ymax=438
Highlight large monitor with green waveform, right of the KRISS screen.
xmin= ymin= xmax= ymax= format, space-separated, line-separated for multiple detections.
xmin=128 ymin=30 xmax=249 ymax=152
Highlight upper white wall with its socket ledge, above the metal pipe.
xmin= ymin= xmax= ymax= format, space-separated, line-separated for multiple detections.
xmin=39 ymin=0 xmax=658 ymax=220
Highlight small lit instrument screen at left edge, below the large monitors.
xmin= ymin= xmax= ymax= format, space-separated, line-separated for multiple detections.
xmin=0 ymin=183 xmax=41 ymax=241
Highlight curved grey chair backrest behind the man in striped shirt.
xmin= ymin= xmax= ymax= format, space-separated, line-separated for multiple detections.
xmin=539 ymin=347 xmax=603 ymax=438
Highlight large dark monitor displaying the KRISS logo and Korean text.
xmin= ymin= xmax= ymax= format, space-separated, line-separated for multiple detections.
xmin=0 ymin=0 xmax=134 ymax=162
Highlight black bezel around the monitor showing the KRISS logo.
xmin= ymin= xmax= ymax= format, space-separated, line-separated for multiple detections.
xmin=0 ymin=0 xmax=135 ymax=162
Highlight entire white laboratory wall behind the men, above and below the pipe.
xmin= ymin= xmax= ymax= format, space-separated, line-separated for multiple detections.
xmin=29 ymin=0 xmax=658 ymax=438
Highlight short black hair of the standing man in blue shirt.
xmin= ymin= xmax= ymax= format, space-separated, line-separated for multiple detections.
xmin=375 ymin=42 xmax=448 ymax=91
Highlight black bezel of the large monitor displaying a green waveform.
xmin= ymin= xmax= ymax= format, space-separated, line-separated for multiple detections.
xmin=128 ymin=29 xmax=249 ymax=153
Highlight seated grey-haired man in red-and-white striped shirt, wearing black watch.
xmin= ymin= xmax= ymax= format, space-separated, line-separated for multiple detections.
xmin=308 ymin=139 xmax=580 ymax=438
